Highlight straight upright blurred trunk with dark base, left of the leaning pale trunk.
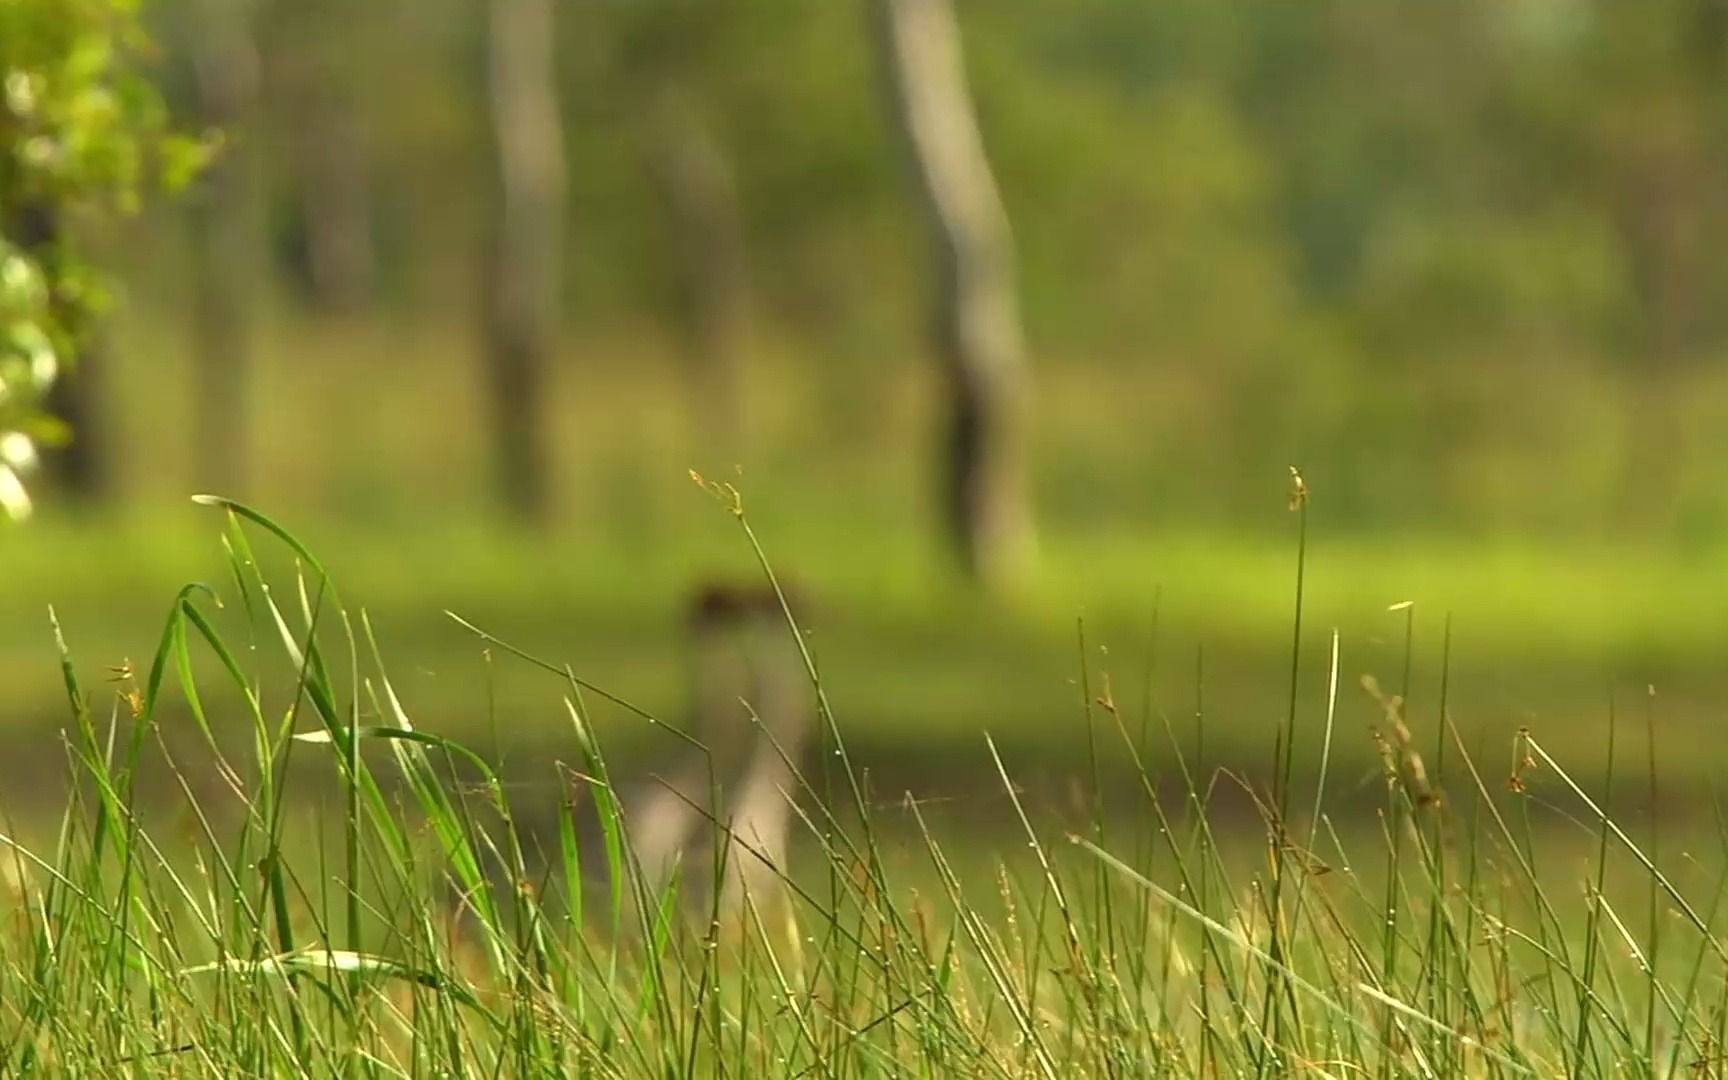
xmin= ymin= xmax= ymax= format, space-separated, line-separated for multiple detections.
xmin=487 ymin=0 xmax=565 ymax=524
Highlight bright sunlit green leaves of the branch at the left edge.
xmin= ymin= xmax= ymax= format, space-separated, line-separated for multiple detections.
xmin=0 ymin=0 xmax=202 ymax=517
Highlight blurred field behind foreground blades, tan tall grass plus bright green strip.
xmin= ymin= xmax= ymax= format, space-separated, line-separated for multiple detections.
xmin=0 ymin=309 xmax=1700 ymax=791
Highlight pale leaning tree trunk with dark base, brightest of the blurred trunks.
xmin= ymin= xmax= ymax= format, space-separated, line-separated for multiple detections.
xmin=873 ymin=0 xmax=1032 ymax=591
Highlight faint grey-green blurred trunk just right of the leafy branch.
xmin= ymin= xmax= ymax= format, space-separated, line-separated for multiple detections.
xmin=190 ymin=0 xmax=259 ymax=494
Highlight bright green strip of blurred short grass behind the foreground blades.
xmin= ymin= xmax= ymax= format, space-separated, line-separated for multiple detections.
xmin=10 ymin=497 xmax=1728 ymax=802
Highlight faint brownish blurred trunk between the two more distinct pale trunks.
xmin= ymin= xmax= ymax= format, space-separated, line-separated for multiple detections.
xmin=650 ymin=85 xmax=750 ymax=463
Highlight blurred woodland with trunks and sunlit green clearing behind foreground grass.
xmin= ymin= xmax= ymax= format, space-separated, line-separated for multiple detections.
xmin=10 ymin=0 xmax=1728 ymax=791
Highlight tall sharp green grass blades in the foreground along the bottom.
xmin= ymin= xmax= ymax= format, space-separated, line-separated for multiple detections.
xmin=0 ymin=501 xmax=1728 ymax=1078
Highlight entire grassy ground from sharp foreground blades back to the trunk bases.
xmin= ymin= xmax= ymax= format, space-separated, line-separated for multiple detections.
xmin=10 ymin=311 xmax=1728 ymax=1077
